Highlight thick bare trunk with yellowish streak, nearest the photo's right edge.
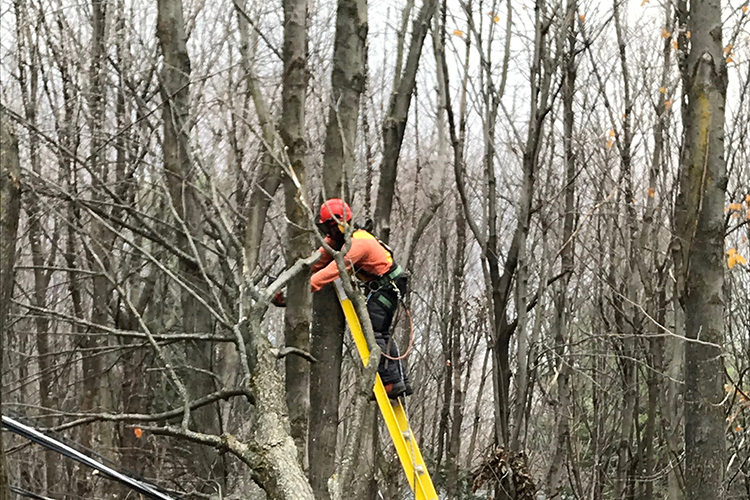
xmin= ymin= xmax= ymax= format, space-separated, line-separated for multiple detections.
xmin=675 ymin=0 xmax=727 ymax=500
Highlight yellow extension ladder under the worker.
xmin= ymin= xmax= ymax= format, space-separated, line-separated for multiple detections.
xmin=335 ymin=278 xmax=438 ymax=500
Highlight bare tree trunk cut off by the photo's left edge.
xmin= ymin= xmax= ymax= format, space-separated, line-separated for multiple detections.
xmin=0 ymin=112 xmax=21 ymax=500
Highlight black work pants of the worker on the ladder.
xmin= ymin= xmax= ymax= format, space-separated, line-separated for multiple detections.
xmin=367 ymin=281 xmax=409 ymax=384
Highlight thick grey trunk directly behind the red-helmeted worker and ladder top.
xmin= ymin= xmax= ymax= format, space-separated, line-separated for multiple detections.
xmin=310 ymin=0 xmax=373 ymax=492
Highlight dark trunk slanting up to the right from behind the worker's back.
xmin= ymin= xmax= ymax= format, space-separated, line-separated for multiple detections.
xmin=374 ymin=0 xmax=437 ymax=243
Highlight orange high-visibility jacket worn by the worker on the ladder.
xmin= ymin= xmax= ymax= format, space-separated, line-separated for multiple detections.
xmin=310 ymin=229 xmax=393 ymax=292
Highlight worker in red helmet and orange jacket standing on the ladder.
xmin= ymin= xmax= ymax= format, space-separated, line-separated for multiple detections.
xmin=310 ymin=198 xmax=413 ymax=399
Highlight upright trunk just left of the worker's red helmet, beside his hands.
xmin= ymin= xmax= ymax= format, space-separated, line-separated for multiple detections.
xmin=281 ymin=0 xmax=312 ymax=470
